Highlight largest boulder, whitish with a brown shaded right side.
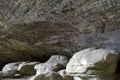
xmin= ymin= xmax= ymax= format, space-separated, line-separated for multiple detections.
xmin=66 ymin=48 xmax=118 ymax=77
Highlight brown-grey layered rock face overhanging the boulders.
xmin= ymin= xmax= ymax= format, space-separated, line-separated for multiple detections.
xmin=0 ymin=0 xmax=120 ymax=65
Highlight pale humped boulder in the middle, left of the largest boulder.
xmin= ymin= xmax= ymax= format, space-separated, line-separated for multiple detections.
xmin=35 ymin=55 xmax=68 ymax=74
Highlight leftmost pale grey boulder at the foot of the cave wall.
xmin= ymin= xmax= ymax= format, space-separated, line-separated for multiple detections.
xmin=2 ymin=62 xmax=21 ymax=77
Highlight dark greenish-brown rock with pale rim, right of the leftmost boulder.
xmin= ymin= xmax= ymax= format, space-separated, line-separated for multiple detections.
xmin=18 ymin=62 xmax=38 ymax=75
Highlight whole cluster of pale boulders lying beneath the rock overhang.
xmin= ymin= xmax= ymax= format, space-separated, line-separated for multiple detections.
xmin=1 ymin=48 xmax=118 ymax=80
